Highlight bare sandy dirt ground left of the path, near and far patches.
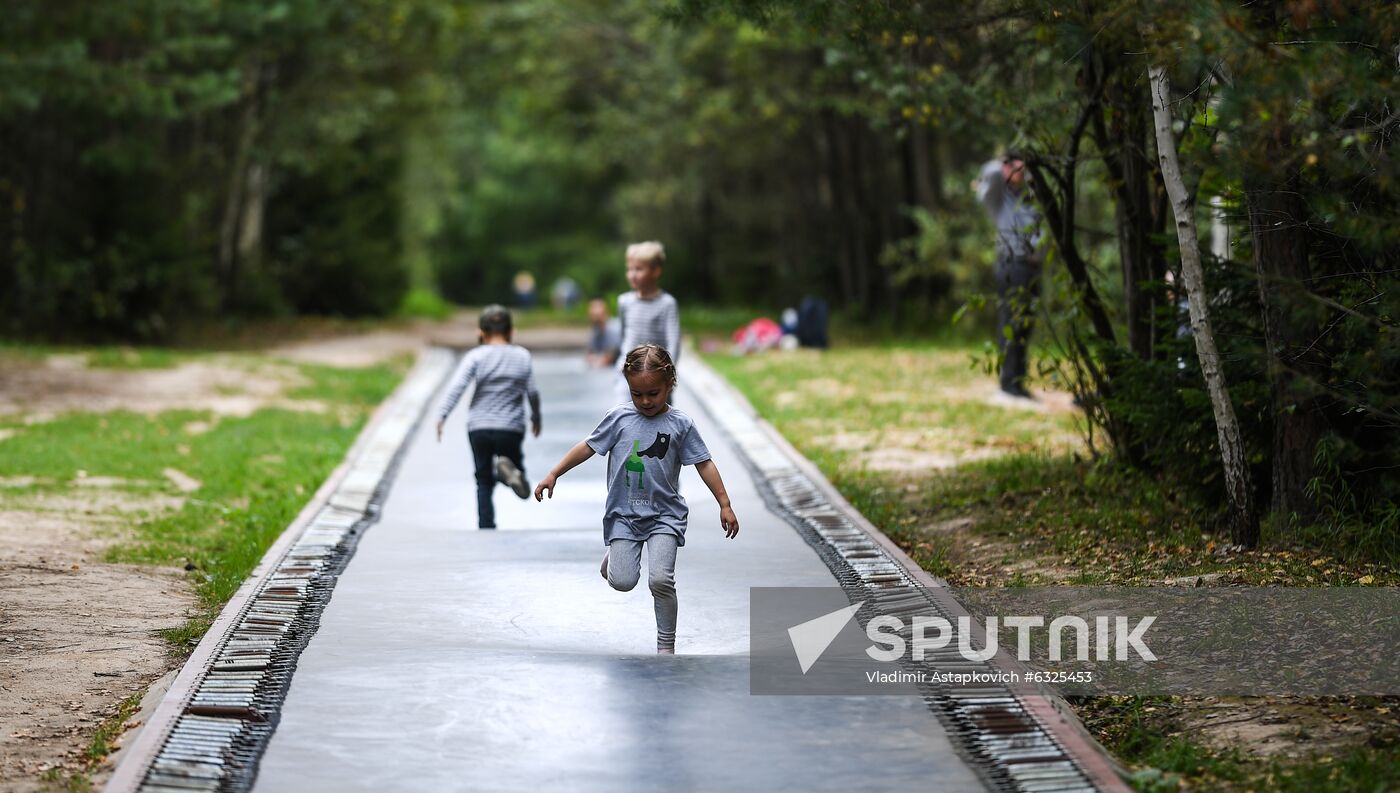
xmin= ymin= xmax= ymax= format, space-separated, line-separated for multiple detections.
xmin=0 ymin=314 xmax=584 ymax=793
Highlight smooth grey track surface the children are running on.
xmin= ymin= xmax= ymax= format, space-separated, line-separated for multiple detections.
xmin=255 ymin=356 xmax=983 ymax=793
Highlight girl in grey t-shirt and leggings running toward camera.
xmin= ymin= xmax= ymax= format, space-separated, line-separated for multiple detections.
xmin=535 ymin=345 xmax=739 ymax=654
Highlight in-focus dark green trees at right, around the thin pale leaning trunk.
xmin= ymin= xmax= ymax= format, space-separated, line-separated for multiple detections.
xmin=680 ymin=0 xmax=1400 ymax=553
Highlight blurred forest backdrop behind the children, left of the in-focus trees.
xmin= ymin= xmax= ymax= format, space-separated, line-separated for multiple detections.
xmin=0 ymin=0 xmax=995 ymax=339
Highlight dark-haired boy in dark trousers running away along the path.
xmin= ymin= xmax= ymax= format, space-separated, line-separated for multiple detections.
xmin=437 ymin=305 xmax=539 ymax=528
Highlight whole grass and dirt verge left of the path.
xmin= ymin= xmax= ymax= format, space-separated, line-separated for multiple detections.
xmin=0 ymin=339 xmax=413 ymax=790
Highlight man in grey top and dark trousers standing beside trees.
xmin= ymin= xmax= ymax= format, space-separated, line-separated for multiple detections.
xmin=973 ymin=151 xmax=1040 ymax=399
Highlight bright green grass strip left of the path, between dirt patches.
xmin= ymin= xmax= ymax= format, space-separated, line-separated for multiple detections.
xmin=0 ymin=359 xmax=407 ymax=651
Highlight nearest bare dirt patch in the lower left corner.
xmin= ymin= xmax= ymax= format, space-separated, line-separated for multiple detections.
xmin=0 ymin=489 xmax=195 ymax=792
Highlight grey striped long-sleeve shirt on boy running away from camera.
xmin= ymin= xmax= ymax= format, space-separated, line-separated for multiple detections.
xmin=438 ymin=345 xmax=539 ymax=432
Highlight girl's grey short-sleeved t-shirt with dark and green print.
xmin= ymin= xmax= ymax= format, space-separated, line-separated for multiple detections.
xmin=585 ymin=402 xmax=710 ymax=545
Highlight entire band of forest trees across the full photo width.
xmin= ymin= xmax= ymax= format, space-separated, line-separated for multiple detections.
xmin=0 ymin=0 xmax=1400 ymax=551
